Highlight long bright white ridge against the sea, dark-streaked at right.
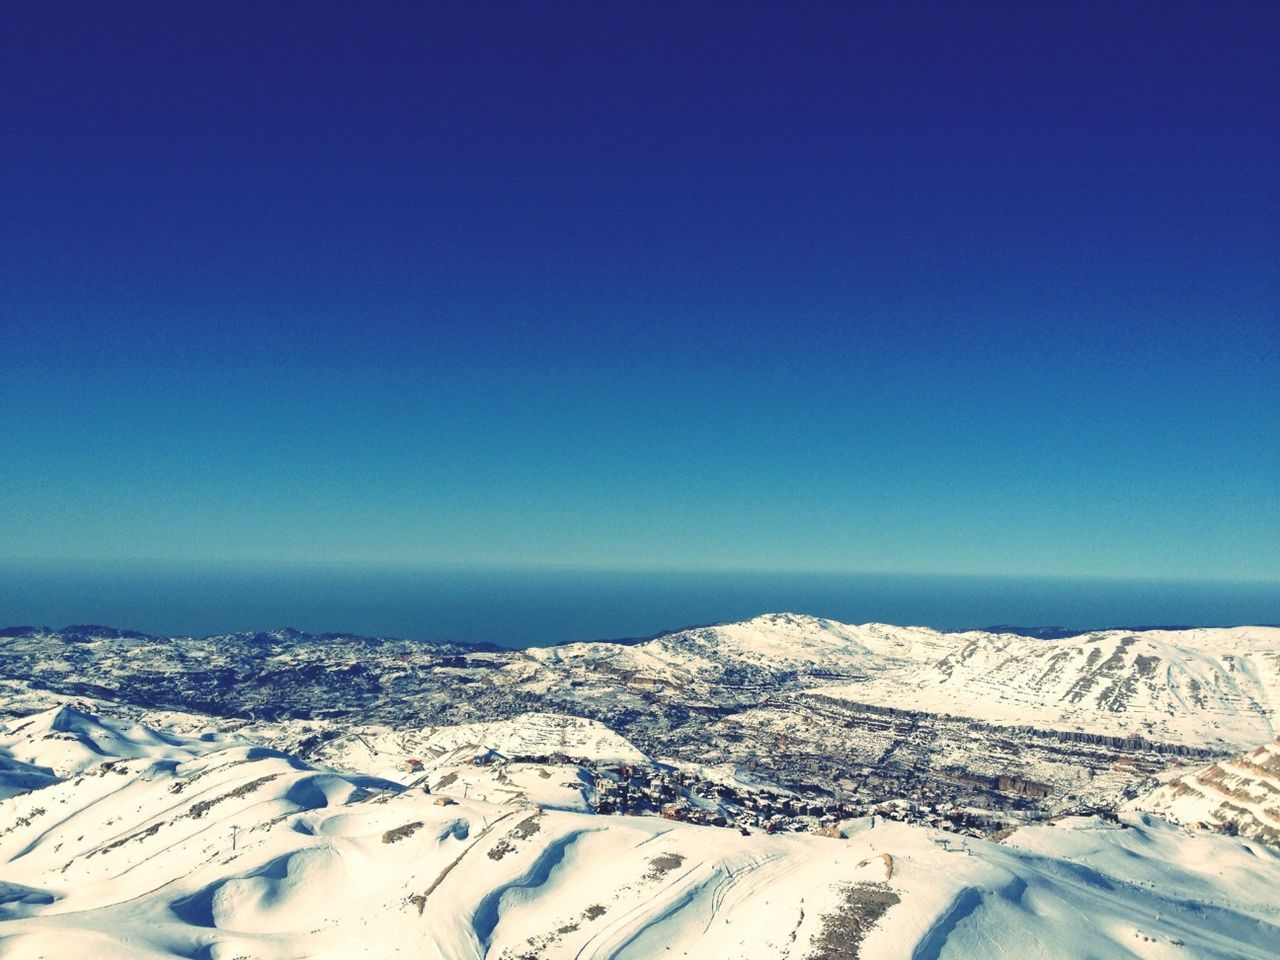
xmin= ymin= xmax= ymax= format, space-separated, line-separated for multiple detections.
xmin=526 ymin=613 xmax=1280 ymax=749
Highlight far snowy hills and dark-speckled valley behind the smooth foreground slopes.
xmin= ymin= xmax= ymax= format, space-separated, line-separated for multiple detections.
xmin=0 ymin=614 xmax=1280 ymax=828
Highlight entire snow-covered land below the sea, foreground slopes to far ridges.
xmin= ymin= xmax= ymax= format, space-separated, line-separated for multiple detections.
xmin=0 ymin=614 xmax=1280 ymax=960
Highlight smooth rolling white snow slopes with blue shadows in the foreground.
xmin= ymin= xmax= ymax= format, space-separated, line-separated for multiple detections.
xmin=0 ymin=710 xmax=1280 ymax=960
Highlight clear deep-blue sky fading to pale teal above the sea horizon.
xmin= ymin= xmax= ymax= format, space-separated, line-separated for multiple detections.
xmin=0 ymin=3 xmax=1280 ymax=580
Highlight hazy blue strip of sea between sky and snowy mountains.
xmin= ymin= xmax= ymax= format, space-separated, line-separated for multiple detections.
xmin=0 ymin=562 xmax=1280 ymax=648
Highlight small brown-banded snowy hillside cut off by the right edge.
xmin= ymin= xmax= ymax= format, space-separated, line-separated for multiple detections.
xmin=1133 ymin=740 xmax=1280 ymax=847
